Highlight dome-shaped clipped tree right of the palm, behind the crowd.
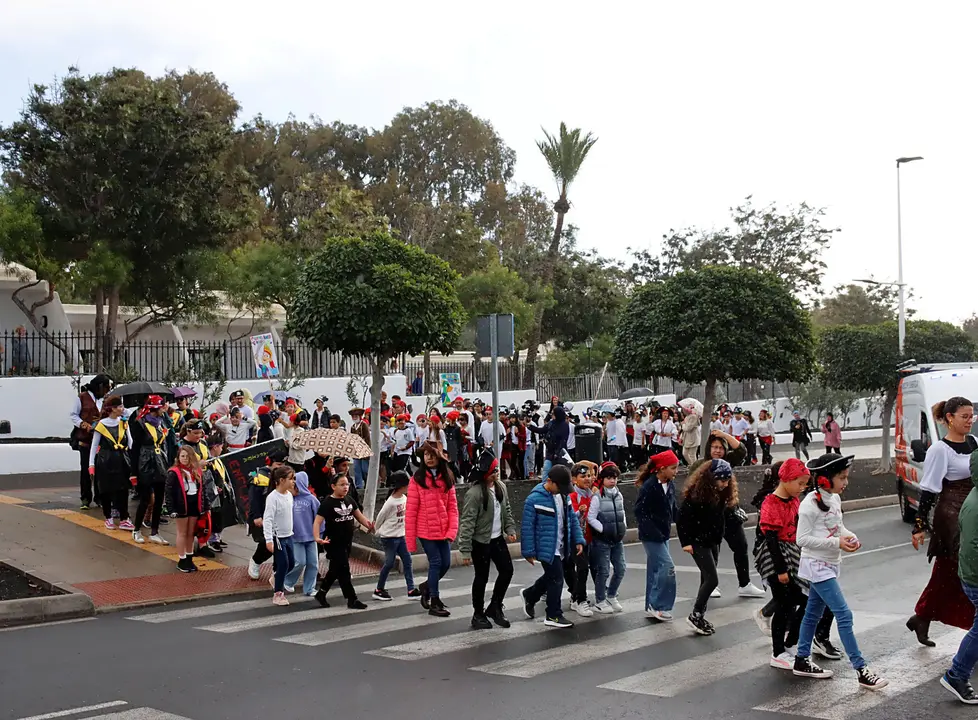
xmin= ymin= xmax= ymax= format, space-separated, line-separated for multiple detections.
xmin=614 ymin=267 xmax=814 ymax=452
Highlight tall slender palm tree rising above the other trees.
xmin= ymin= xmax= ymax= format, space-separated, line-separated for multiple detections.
xmin=524 ymin=123 xmax=598 ymax=387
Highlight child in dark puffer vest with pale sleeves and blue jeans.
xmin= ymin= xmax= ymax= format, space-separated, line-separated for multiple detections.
xmin=587 ymin=462 xmax=626 ymax=615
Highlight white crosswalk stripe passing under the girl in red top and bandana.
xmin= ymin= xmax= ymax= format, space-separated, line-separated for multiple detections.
xmin=598 ymin=613 xmax=902 ymax=697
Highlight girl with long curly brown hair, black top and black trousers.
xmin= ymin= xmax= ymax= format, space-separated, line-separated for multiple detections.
xmin=676 ymin=459 xmax=738 ymax=635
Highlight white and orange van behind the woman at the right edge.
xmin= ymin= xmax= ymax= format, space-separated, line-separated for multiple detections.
xmin=895 ymin=363 xmax=978 ymax=523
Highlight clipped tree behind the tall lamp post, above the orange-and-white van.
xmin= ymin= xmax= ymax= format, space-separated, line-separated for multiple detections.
xmin=818 ymin=320 xmax=978 ymax=472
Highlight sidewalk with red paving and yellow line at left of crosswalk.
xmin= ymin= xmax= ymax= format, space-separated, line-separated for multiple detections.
xmin=0 ymin=488 xmax=379 ymax=612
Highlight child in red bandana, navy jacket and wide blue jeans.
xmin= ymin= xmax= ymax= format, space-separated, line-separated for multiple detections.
xmin=635 ymin=450 xmax=679 ymax=622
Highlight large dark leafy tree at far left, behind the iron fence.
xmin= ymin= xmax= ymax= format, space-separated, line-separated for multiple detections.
xmin=0 ymin=69 xmax=247 ymax=366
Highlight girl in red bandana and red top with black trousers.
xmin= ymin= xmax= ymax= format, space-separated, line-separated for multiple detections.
xmin=754 ymin=458 xmax=809 ymax=670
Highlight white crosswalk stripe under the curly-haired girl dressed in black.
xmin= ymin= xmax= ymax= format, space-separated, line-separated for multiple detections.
xmin=469 ymin=603 xmax=756 ymax=678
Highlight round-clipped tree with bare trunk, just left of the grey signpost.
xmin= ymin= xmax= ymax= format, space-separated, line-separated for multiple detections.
xmin=288 ymin=232 xmax=466 ymax=517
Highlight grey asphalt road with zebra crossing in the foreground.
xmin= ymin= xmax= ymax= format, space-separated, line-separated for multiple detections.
xmin=0 ymin=508 xmax=964 ymax=720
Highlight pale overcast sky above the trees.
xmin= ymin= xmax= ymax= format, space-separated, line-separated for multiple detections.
xmin=0 ymin=0 xmax=978 ymax=323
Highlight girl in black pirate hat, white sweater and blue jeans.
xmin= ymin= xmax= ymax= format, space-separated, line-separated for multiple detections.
xmin=794 ymin=454 xmax=888 ymax=690
